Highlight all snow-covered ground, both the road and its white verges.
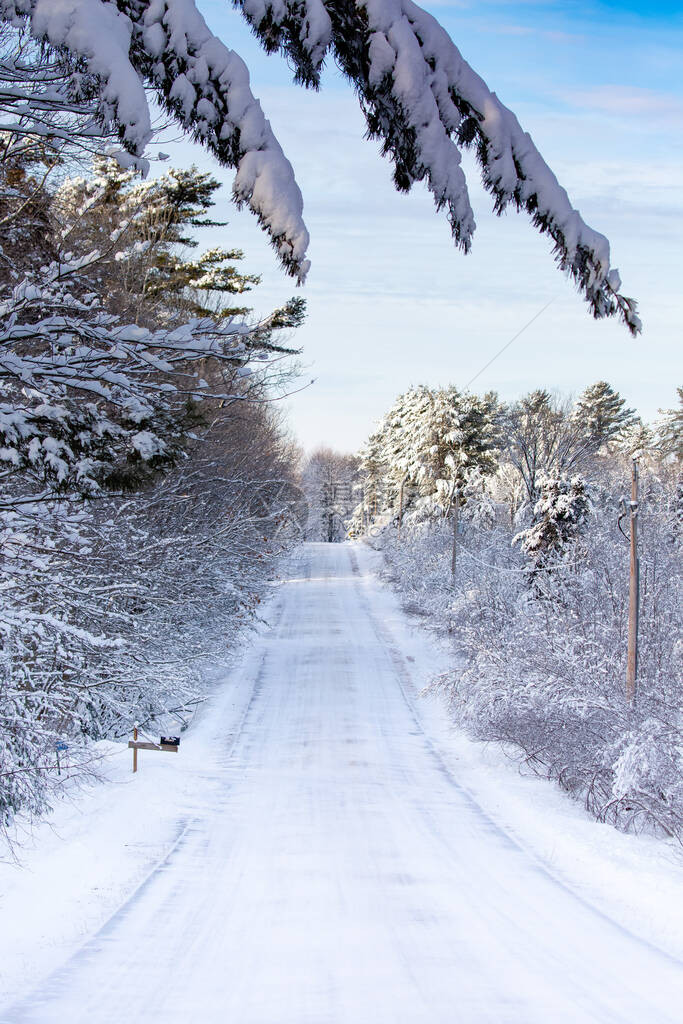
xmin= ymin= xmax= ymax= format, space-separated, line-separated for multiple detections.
xmin=0 ymin=545 xmax=683 ymax=1024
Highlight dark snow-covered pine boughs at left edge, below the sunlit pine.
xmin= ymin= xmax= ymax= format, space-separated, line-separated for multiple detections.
xmin=0 ymin=261 xmax=297 ymax=497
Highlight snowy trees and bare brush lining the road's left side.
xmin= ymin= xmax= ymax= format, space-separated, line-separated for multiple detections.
xmin=0 ymin=25 xmax=304 ymax=825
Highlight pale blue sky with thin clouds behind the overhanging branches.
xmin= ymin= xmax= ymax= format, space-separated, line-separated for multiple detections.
xmin=164 ymin=0 xmax=683 ymax=450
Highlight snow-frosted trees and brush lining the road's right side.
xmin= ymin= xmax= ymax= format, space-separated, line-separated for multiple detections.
xmin=350 ymin=381 xmax=683 ymax=837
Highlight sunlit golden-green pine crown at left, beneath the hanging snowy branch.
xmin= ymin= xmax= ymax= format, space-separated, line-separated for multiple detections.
xmin=52 ymin=157 xmax=260 ymax=324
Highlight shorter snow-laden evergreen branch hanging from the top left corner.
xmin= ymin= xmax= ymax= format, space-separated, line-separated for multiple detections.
xmin=0 ymin=0 xmax=309 ymax=282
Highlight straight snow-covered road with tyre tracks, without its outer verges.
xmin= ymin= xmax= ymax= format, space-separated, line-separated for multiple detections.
xmin=5 ymin=545 xmax=683 ymax=1024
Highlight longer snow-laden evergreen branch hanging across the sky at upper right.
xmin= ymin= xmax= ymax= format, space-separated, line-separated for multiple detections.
xmin=237 ymin=0 xmax=640 ymax=335
